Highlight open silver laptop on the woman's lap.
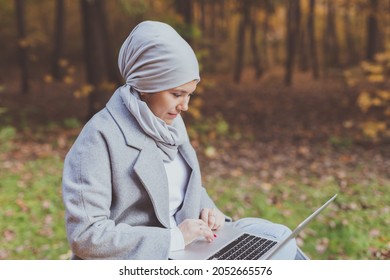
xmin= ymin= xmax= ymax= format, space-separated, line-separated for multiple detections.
xmin=169 ymin=194 xmax=337 ymax=260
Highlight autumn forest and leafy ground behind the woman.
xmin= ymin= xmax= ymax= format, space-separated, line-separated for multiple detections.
xmin=0 ymin=0 xmax=390 ymax=260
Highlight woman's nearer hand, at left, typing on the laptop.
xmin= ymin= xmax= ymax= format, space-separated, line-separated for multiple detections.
xmin=178 ymin=219 xmax=214 ymax=245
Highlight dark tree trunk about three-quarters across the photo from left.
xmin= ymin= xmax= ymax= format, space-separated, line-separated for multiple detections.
xmin=284 ymin=0 xmax=300 ymax=85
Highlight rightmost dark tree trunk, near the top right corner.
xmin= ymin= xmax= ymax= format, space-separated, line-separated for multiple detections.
xmin=366 ymin=0 xmax=379 ymax=60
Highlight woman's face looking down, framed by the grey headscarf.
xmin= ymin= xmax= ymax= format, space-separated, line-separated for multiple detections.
xmin=141 ymin=81 xmax=197 ymax=125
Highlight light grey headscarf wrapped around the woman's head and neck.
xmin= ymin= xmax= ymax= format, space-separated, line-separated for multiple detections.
xmin=117 ymin=21 xmax=200 ymax=162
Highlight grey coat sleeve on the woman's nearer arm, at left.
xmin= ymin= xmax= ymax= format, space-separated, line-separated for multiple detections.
xmin=62 ymin=117 xmax=170 ymax=259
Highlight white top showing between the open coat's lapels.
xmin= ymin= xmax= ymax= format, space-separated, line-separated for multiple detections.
xmin=164 ymin=153 xmax=191 ymax=251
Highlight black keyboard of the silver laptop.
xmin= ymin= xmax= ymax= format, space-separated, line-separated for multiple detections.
xmin=209 ymin=233 xmax=276 ymax=260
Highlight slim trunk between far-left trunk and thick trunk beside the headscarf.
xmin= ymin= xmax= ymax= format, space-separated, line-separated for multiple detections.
xmin=52 ymin=0 xmax=65 ymax=80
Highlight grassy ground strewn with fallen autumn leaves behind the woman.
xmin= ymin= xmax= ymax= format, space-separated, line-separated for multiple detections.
xmin=0 ymin=68 xmax=390 ymax=259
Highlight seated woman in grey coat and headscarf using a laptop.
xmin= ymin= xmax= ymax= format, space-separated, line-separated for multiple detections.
xmin=63 ymin=21 xmax=308 ymax=259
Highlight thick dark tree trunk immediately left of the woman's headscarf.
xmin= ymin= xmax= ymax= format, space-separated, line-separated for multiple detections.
xmin=80 ymin=0 xmax=106 ymax=119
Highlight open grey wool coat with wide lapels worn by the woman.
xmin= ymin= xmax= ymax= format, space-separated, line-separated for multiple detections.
xmin=62 ymin=91 xmax=216 ymax=259
